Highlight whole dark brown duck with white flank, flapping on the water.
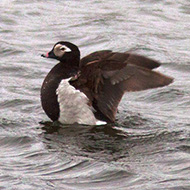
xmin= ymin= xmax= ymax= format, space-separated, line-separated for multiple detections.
xmin=41 ymin=41 xmax=173 ymax=125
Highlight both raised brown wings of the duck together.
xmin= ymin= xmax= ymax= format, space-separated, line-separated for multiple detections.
xmin=72 ymin=51 xmax=173 ymax=122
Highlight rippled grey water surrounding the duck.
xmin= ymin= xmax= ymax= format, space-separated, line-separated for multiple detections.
xmin=0 ymin=0 xmax=190 ymax=190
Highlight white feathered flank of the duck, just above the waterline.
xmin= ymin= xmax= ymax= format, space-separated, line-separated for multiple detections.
xmin=56 ymin=78 xmax=106 ymax=125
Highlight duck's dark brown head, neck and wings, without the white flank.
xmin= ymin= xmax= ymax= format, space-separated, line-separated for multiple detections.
xmin=41 ymin=42 xmax=173 ymax=122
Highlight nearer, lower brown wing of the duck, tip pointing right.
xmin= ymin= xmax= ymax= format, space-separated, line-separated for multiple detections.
xmin=97 ymin=64 xmax=173 ymax=121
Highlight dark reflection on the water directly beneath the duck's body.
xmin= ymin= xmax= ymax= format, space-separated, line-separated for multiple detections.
xmin=43 ymin=123 xmax=127 ymax=161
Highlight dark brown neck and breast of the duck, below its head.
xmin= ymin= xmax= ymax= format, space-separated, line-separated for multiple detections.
xmin=41 ymin=62 xmax=79 ymax=121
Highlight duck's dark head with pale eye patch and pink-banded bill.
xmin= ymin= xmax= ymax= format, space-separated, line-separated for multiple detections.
xmin=41 ymin=41 xmax=80 ymax=64
